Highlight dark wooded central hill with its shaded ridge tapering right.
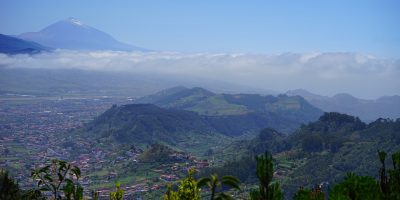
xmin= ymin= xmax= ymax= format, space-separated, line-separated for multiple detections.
xmin=77 ymin=104 xmax=316 ymax=153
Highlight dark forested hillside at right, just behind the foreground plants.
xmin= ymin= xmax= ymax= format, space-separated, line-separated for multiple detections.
xmin=203 ymin=113 xmax=400 ymax=198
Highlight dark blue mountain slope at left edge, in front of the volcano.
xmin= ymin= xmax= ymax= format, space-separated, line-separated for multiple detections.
xmin=0 ymin=34 xmax=51 ymax=54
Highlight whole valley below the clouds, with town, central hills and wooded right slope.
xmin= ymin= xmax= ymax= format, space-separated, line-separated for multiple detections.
xmin=0 ymin=87 xmax=400 ymax=199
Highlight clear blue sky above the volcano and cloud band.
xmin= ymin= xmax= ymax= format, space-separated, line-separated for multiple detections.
xmin=0 ymin=0 xmax=400 ymax=58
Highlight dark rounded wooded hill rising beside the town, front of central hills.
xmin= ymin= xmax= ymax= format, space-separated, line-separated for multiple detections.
xmin=78 ymin=104 xmax=231 ymax=155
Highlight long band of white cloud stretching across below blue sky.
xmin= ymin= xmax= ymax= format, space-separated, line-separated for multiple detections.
xmin=0 ymin=50 xmax=400 ymax=98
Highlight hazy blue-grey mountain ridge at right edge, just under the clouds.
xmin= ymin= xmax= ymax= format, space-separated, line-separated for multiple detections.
xmin=286 ymin=89 xmax=400 ymax=121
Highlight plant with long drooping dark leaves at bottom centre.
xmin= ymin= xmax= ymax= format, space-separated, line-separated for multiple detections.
xmin=197 ymin=174 xmax=240 ymax=200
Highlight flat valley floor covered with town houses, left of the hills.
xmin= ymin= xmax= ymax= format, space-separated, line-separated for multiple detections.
xmin=0 ymin=96 xmax=212 ymax=196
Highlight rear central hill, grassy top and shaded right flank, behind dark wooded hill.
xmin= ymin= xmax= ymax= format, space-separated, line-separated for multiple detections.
xmin=136 ymin=87 xmax=323 ymax=135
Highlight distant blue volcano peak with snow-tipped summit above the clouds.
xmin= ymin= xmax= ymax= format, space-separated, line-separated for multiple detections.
xmin=19 ymin=18 xmax=146 ymax=51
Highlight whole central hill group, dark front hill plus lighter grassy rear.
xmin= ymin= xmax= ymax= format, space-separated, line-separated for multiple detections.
xmin=79 ymin=87 xmax=323 ymax=148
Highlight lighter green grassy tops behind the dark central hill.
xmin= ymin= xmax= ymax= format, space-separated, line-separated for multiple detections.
xmin=136 ymin=87 xmax=322 ymax=114
